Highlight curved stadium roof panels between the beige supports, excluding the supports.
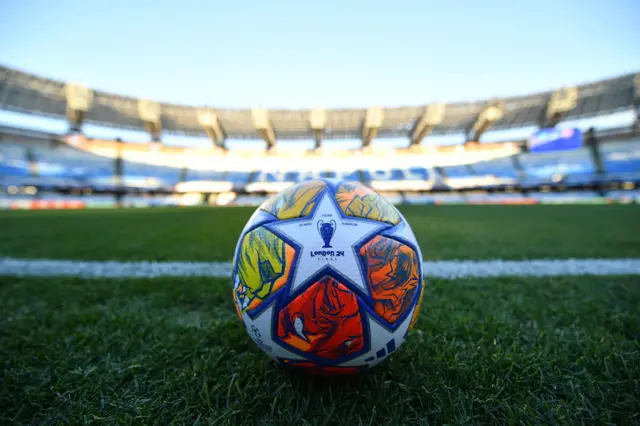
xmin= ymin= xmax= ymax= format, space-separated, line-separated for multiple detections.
xmin=0 ymin=66 xmax=636 ymax=140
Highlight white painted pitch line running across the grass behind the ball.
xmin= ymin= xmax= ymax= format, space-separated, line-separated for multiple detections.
xmin=0 ymin=258 xmax=640 ymax=279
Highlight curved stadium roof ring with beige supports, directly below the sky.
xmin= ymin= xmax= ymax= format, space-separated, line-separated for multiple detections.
xmin=0 ymin=67 xmax=635 ymax=141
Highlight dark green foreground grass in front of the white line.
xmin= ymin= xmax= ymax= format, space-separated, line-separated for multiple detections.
xmin=0 ymin=277 xmax=640 ymax=425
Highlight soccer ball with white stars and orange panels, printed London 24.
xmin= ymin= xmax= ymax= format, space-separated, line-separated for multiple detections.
xmin=233 ymin=180 xmax=424 ymax=374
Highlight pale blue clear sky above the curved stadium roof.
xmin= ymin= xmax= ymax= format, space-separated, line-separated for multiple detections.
xmin=0 ymin=0 xmax=640 ymax=146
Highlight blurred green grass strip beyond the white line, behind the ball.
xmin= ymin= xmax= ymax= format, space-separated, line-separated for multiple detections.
xmin=0 ymin=205 xmax=640 ymax=261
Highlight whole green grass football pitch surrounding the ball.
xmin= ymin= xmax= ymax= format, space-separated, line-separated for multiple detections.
xmin=0 ymin=205 xmax=640 ymax=425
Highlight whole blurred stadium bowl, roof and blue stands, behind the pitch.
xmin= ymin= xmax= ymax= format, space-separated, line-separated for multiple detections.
xmin=0 ymin=67 xmax=640 ymax=208
